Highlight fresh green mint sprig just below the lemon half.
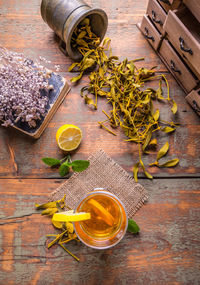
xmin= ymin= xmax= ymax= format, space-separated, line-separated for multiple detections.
xmin=42 ymin=155 xmax=90 ymax=177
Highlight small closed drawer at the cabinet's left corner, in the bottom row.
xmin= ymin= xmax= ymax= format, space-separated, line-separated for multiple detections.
xmin=140 ymin=15 xmax=162 ymax=50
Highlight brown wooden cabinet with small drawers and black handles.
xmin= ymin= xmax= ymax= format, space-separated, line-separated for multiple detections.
xmin=138 ymin=0 xmax=200 ymax=115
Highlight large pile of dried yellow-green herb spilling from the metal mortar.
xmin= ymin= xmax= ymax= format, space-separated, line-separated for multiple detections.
xmin=69 ymin=19 xmax=178 ymax=181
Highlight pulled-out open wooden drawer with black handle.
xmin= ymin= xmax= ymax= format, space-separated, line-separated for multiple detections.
xmin=164 ymin=7 xmax=200 ymax=74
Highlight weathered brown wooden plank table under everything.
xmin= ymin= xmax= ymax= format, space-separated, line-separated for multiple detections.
xmin=0 ymin=0 xmax=200 ymax=285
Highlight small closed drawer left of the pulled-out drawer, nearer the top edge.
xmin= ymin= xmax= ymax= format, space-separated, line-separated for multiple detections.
xmin=147 ymin=0 xmax=167 ymax=35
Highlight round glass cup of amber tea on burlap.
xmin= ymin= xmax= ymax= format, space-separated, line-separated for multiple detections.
xmin=74 ymin=188 xmax=128 ymax=249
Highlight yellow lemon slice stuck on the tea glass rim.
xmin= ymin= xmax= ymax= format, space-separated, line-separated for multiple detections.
xmin=52 ymin=211 xmax=91 ymax=222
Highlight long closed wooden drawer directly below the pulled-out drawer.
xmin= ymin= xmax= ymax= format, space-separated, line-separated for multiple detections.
xmin=159 ymin=40 xmax=198 ymax=93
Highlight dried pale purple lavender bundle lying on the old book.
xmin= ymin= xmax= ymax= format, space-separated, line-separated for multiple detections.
xmin=0 ymin=48 xmax=53 ymax=128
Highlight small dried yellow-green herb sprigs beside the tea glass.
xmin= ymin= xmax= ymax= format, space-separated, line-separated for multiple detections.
xmin=35 ymin=195 xmax=79 ymax=261
